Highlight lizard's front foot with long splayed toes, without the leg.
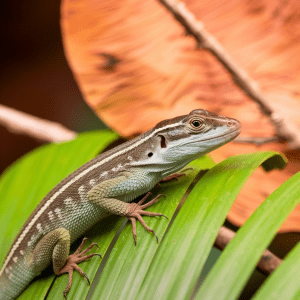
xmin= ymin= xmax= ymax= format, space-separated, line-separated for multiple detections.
xmin=125 ymin=192 xmax=168 ymax=245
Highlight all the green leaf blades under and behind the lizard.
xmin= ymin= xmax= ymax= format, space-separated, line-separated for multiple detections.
xmin=0 ymin=131 xmax=300 ymax=300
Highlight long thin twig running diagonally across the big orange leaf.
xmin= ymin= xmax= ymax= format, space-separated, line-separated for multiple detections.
xmin=159 ymin=0 xmax=300 ymax=149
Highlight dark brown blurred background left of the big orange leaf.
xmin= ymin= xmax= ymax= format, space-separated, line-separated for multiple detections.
xmin=0 ymin=0 xmax=104 ymax=173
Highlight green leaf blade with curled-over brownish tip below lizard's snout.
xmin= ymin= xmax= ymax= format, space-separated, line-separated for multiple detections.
xmin=134 ymin=151 xmax=284 ymax=299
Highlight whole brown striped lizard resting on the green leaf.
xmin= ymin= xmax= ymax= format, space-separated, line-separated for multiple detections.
xmin=0 ymin=109 xmax=241 ymax=300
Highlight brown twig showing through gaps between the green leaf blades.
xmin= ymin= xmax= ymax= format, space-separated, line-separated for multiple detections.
xmin=215 ymin=226 xmax=282 ymax=275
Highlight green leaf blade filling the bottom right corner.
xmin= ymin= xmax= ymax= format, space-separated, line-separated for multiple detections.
xmin=252 ymin=237 xmax=300 ymax=300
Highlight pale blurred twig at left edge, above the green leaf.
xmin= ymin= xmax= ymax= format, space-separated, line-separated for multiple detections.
xmin=0 ymin=104 xmax=76 ymax=142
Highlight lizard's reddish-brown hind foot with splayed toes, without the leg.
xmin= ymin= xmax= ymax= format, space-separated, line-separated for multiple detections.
xmin=58 ymin=238 xmax=102 ymax=299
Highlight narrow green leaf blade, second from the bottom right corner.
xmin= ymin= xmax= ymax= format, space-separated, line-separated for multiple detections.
xmin=196 ymin=172 xmax=300 ymax=299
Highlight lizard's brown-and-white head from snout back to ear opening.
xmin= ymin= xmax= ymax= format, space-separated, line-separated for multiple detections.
xmin=154 ymin=109 xmax=241 ymax=171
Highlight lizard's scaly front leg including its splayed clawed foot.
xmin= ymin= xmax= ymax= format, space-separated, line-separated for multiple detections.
xmin=88 ymin=172 xmax=167 ymax=244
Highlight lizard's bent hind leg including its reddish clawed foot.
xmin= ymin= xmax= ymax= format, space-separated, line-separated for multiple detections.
xmin=30 ymin=228 xmax=101 ymax=299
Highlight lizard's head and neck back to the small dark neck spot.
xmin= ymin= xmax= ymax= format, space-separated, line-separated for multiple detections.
xmin=130 ymin=109 xmax=241 ymax=176
